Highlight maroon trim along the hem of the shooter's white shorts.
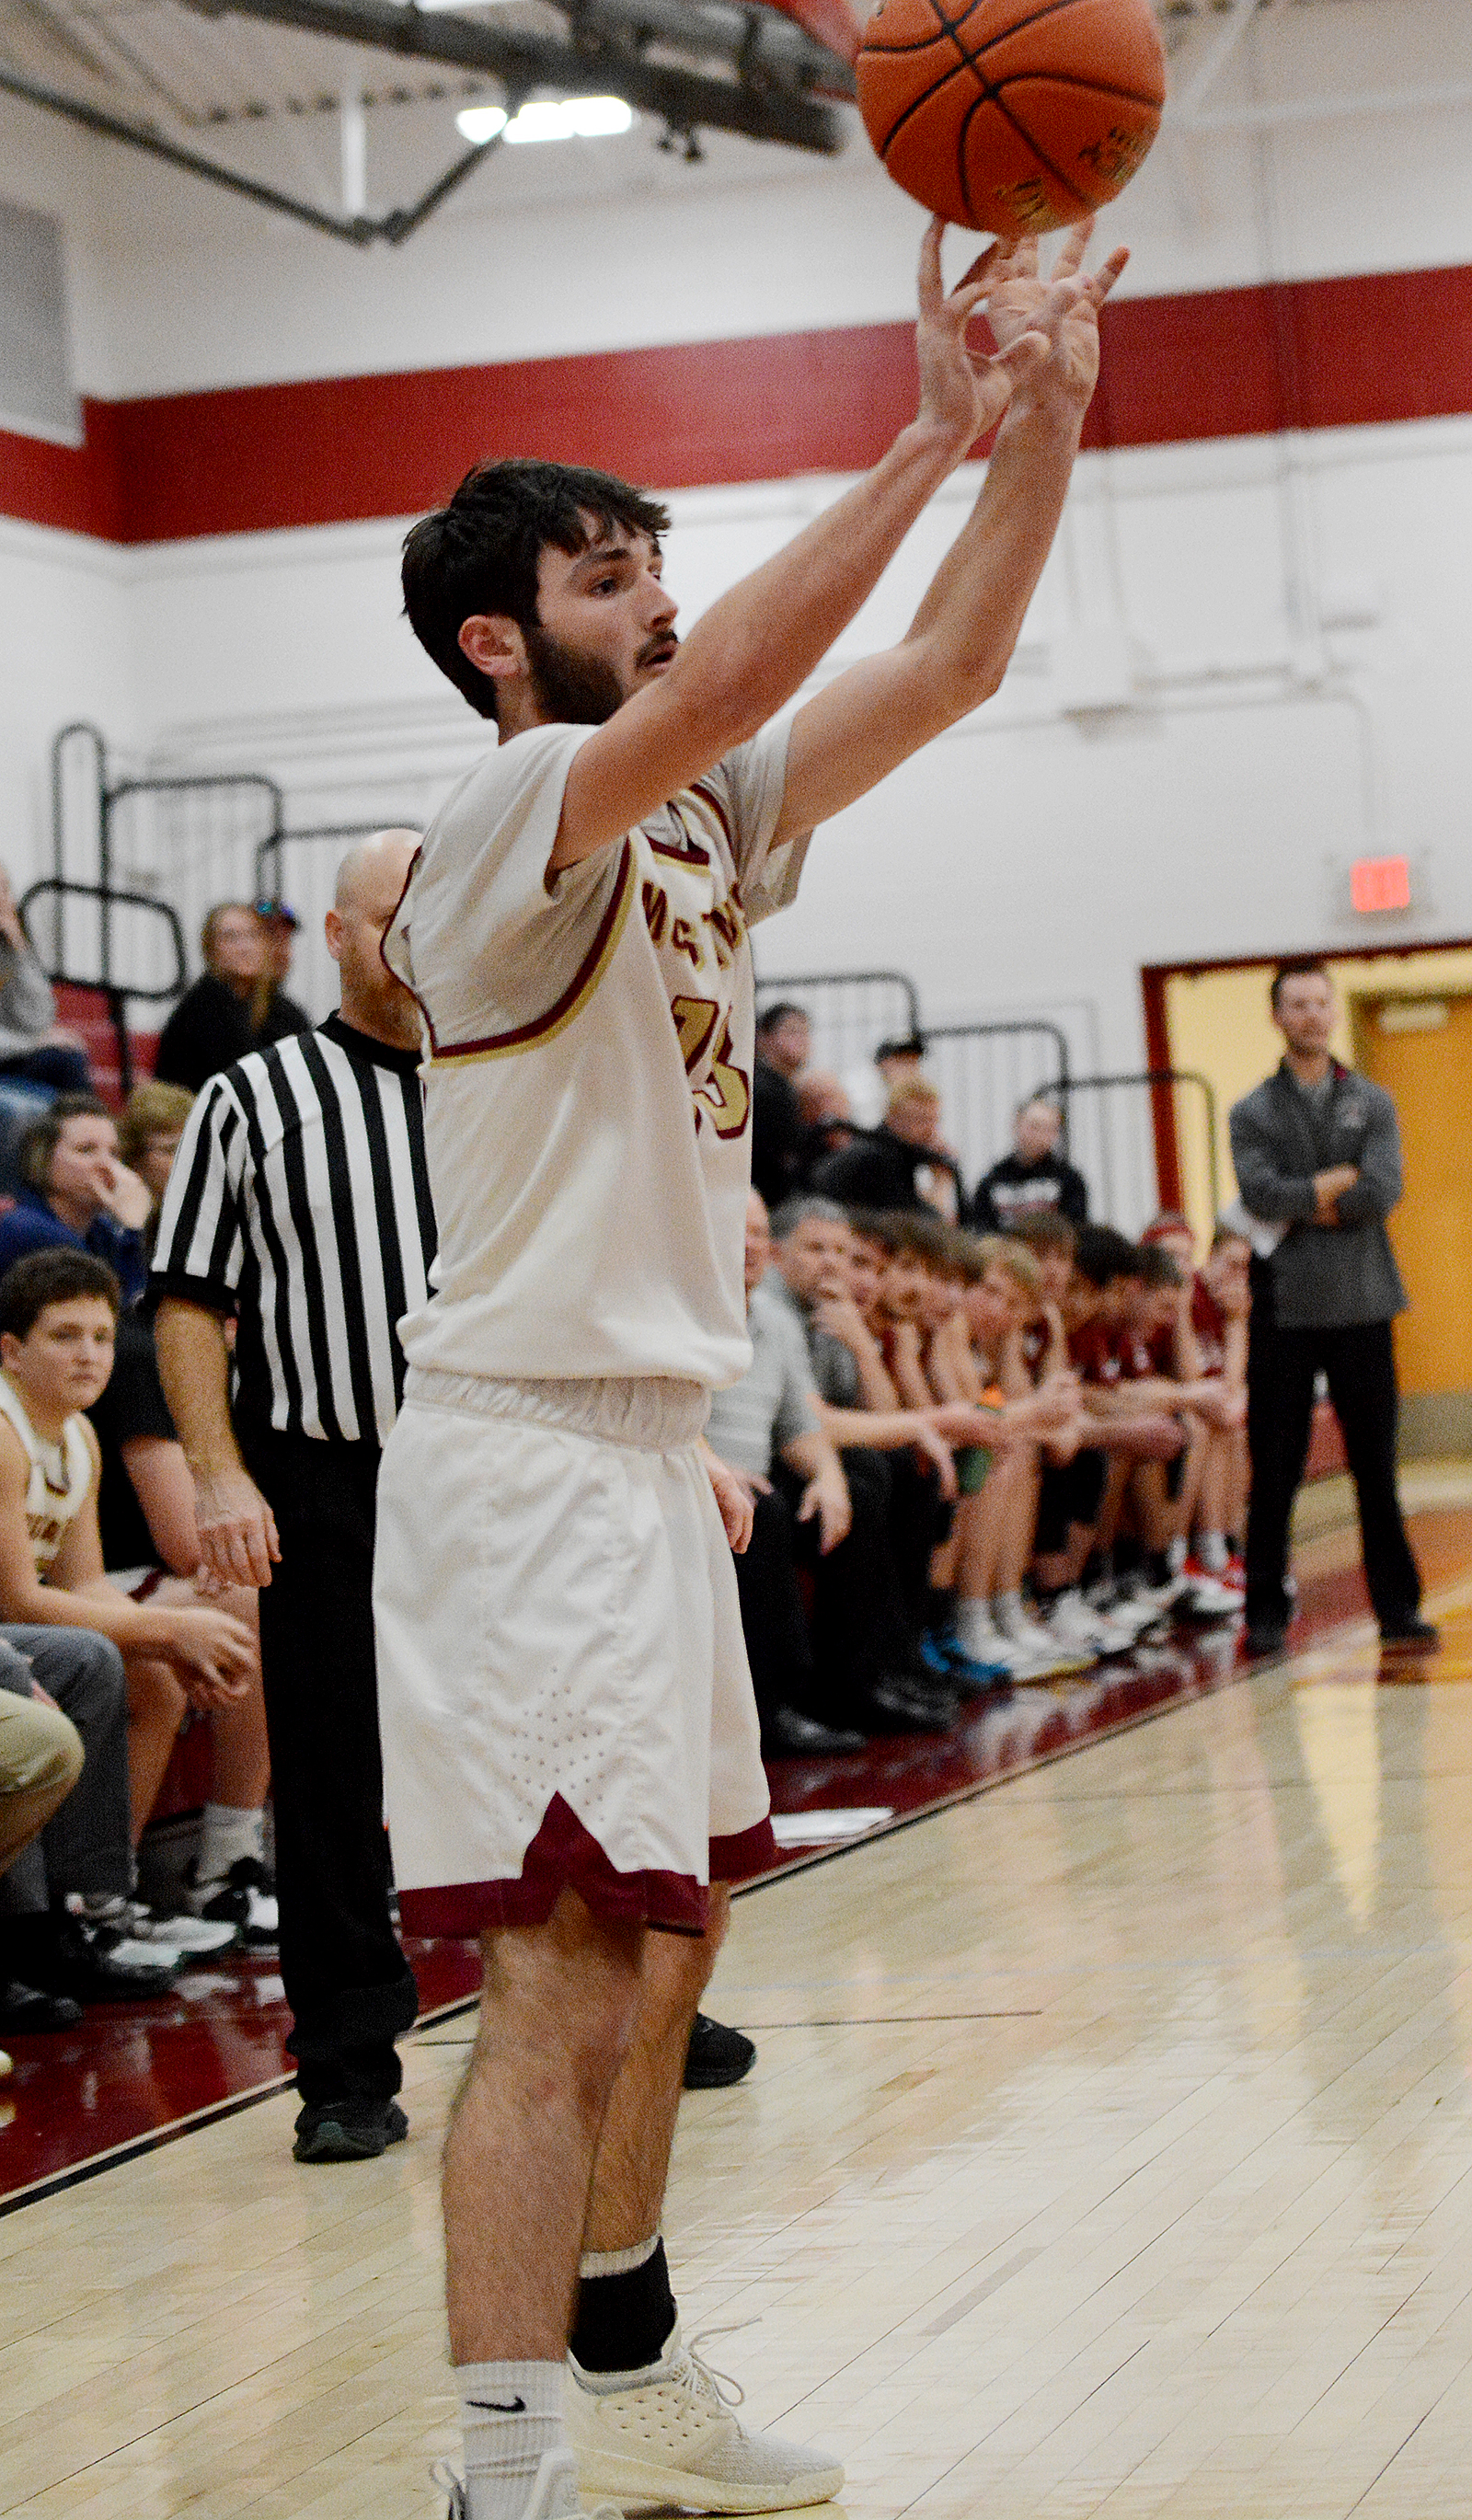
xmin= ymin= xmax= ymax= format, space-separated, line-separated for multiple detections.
xmin=398 ymin=1794 xmax=706 ymax=1940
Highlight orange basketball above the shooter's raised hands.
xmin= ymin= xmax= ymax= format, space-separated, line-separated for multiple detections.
xmin=857 ymin=0 xmax=1165 ymax=236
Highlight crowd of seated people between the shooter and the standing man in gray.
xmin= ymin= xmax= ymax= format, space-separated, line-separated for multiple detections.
xmin=730 ymin=1006 xmax=1248 ymax=1754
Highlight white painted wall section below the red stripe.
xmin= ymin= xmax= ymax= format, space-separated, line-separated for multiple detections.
xmin=0 ymin=403 xmax=1472 ymax=1194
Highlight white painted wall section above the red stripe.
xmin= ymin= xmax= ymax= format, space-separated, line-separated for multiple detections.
xmin=0 ymin=0 xmax=1472 ymax=393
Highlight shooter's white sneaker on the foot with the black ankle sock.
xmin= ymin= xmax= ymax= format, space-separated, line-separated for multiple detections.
xmin=567 ymin=2321 xmax=845 ymax=2513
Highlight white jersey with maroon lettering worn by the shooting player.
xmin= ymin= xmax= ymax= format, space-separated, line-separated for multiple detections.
xmin=383 ymin=726 xmax=807 ymax=1386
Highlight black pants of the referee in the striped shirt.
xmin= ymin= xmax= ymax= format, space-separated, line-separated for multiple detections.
xmin=242 ymin=1429 xmax=419 ymax=2107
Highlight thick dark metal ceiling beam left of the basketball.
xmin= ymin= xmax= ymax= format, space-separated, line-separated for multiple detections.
xmin=187 ymin=0 xmax=852 ymax=156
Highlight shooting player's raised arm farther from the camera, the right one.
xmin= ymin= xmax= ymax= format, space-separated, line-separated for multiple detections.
xmin=779 ymin=222 xmax=1127 ymax=839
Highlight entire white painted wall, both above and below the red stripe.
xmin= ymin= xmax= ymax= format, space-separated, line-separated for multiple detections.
xmin=0 ymin=0 xmax=1472 ymax=1209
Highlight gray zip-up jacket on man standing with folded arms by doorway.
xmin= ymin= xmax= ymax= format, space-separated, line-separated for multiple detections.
xmin=1230 ymin=1061 xmax=1407 ymax=1330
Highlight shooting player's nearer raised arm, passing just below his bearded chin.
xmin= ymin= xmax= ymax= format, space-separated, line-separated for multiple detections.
xmin=552 ymin=219 xmax=1046 ymax=869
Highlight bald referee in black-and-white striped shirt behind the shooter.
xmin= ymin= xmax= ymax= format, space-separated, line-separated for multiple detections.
xmin=149 ymin=832 xmax=433 ymax=2162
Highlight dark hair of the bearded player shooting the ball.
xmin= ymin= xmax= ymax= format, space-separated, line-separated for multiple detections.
xmin=403 ymin=456 xmax=671 ymax=719
